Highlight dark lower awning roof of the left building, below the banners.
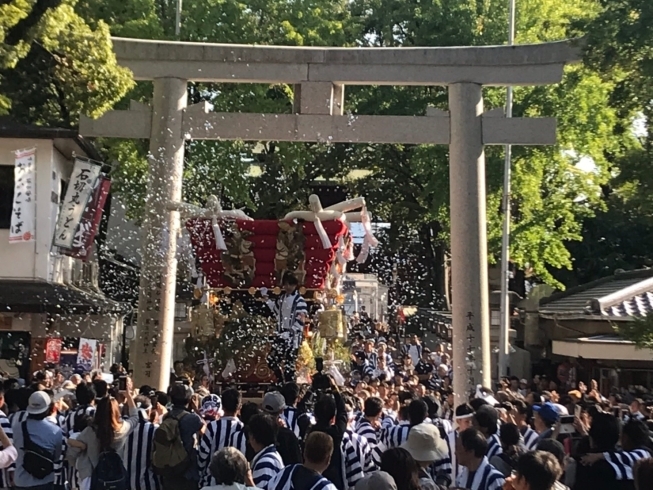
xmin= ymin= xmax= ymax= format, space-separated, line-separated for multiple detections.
xmin=0 ymin=279 xmax=131 ymax=316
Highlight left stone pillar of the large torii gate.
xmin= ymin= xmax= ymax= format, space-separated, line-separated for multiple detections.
xmin=131 ymin=78 xmax=188 ymax=391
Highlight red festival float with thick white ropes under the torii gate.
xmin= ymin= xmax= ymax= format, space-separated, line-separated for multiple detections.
xmin=175 ymin=195 xmax=376 ymax=383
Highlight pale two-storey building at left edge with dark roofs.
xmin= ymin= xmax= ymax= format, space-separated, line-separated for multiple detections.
xmin=0 ymin=121 xmax=129 ymax=378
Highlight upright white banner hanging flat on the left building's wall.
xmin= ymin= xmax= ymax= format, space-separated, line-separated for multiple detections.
xmin=9 ymin=148 xmax=36 ymax=243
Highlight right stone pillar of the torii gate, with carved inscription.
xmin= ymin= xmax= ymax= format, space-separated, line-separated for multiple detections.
xmin=449 ymin=83 xmax=491 ymax=400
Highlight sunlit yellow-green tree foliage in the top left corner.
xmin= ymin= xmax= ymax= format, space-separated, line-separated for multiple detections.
xmin=0 ymin=0 xmax=133 ymax=128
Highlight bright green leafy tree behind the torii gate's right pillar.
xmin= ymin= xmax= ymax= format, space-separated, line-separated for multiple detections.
xmin=338 ymin=0 xmax=618 ymax=298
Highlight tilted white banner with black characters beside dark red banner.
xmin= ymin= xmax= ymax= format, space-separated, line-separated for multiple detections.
xmin=54 ymin=158 xmax=102 ymax=249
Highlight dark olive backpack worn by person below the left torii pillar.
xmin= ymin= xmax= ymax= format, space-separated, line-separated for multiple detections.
xmin=152 ymin=412 xmax=190 ymax=477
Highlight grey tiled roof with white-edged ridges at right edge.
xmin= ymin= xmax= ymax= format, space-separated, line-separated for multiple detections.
xmin=540 ymin=269 xmax=653 ymax=318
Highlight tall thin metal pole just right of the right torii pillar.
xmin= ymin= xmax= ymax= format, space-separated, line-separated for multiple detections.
xmin=497 ymin=0 xmax=515 ymax=379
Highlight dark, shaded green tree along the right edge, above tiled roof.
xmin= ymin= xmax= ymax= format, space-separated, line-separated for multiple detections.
xmin=557 ymin=0 xmax=653 ymax=290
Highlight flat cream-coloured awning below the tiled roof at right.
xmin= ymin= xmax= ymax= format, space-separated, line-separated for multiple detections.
xmin=552 ymin=335 xmax=653 ymax=361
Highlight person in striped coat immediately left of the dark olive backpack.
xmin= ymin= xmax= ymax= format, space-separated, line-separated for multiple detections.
xmin=122 ymin=395 xmax=161 ymax=490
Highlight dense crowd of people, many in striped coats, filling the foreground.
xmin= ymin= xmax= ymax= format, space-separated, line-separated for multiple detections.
xmin=0 ymin=334 xmax=653 ymax=490
